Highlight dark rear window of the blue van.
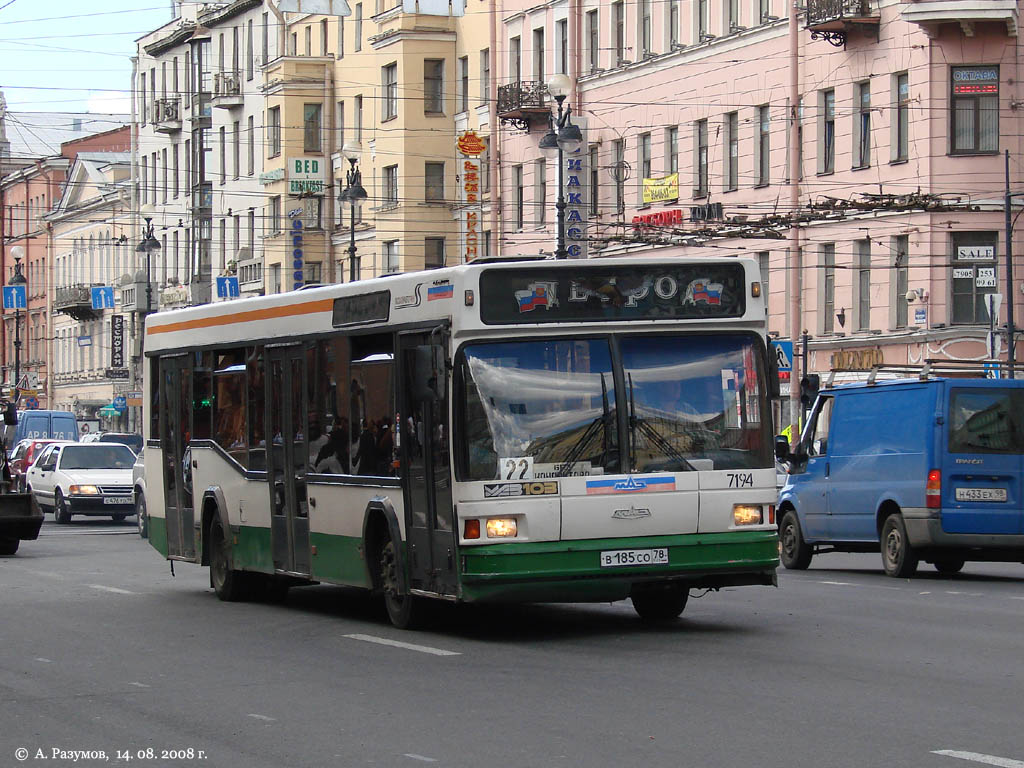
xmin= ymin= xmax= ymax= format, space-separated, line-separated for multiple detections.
xmin=949 ymin=388 xmax=1024 ymax=454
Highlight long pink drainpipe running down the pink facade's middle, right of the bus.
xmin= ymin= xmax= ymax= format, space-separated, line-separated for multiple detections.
xmin=780 ymin=0 xmax=806 ymax=438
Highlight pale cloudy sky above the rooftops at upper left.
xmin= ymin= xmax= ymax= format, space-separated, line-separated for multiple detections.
xmin=0 ymin=0 xmax=172 ymax=114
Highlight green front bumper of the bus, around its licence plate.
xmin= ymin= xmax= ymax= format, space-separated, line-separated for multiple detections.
xmin=460 ymin=530 xmax=778 ymax=602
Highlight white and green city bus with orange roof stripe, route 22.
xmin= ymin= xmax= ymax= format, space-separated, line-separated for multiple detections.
xmin=144 ymin=258 xmax=778 ymax=627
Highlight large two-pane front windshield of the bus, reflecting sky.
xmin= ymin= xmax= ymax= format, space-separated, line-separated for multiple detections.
xmin=458 ymin=334 xmax=771 ymax=480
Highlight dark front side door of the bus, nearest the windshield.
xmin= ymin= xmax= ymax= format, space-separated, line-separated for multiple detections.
xmin=398 ymin=333 xmax=458 ymax=595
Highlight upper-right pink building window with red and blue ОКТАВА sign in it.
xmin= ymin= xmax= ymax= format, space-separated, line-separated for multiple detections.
xmin=950 ymin=67 xmax=999 ymax=155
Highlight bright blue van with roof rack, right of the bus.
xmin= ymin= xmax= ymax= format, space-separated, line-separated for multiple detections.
xmin=776 ymin=377 xmax=1024 ymax=578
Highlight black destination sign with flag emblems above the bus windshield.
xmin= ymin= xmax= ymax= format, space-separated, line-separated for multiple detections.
xmin=480 ymin=263 xmax=745 ymax=325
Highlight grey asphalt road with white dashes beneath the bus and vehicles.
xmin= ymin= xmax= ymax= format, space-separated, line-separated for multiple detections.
xmin=0 ymin=517 xmax=1024 ymax=768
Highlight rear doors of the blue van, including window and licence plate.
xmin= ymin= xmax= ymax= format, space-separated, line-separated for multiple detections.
xmin=940 ymin=382 xmax=1024 ymax=535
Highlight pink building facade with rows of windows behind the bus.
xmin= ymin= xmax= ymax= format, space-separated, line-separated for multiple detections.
xmin=496 ymin=0 xmax=1024 ymax=434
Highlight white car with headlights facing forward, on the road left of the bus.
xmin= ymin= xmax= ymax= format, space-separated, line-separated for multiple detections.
xmin=26 ymin=442 xmax=135 ymax=523
